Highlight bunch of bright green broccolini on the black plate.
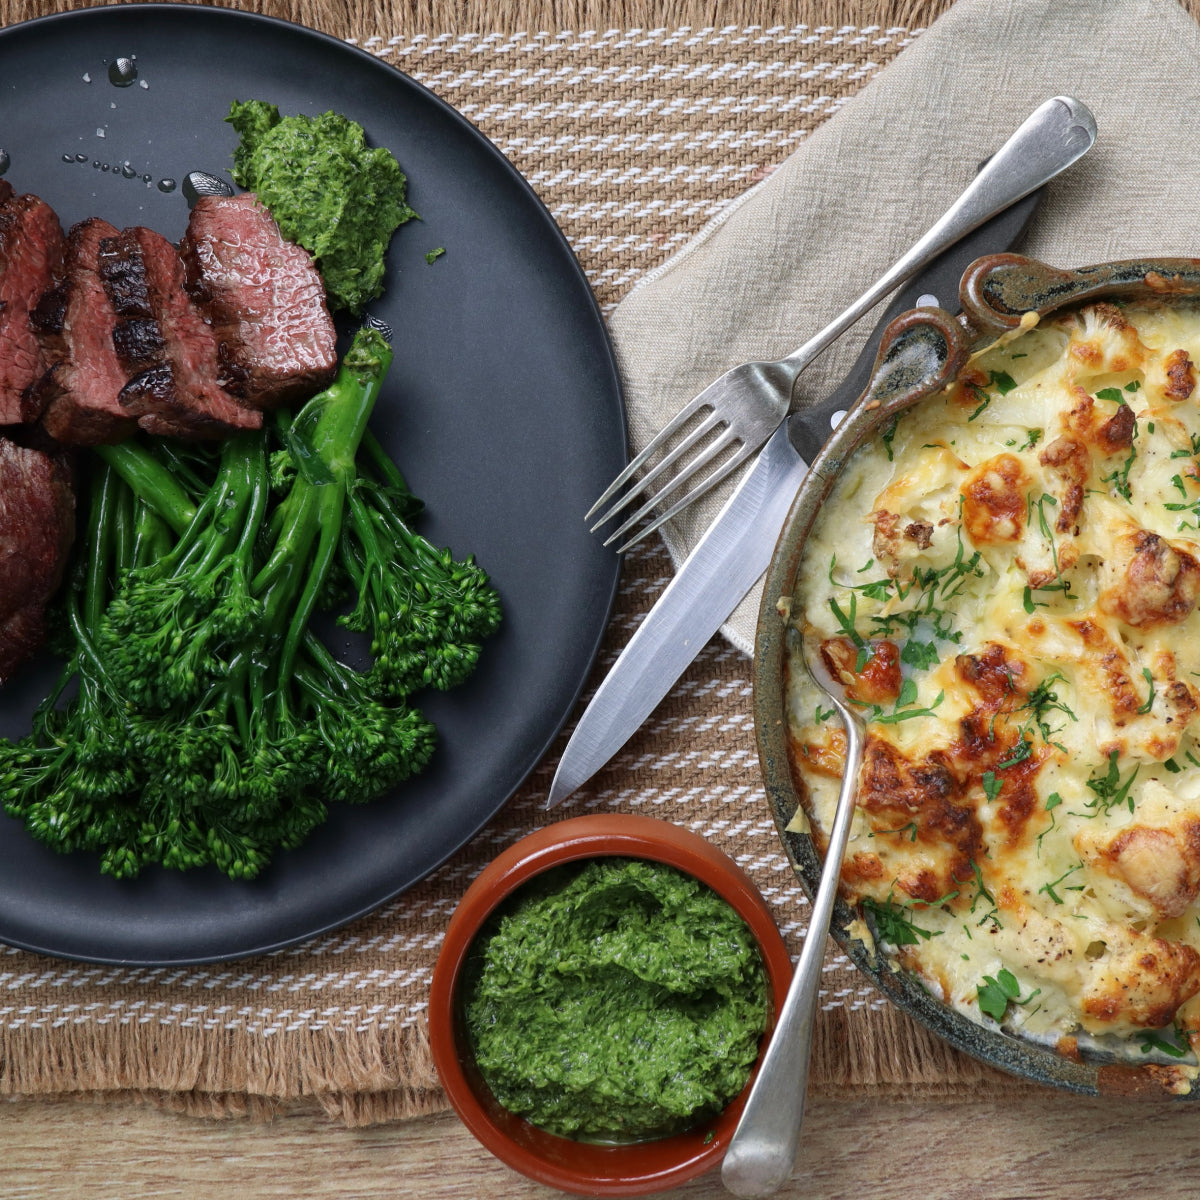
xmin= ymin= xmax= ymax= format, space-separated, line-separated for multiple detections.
xmin=0 ymin=328 xmax=500 ymax=878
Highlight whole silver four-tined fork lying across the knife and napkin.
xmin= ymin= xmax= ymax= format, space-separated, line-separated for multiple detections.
xmin=584 ymin=96 xmax=1096 ymax=553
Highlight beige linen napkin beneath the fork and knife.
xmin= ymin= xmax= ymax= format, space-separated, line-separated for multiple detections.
xmin=611 ymin=0 xmax=1200 ymax=653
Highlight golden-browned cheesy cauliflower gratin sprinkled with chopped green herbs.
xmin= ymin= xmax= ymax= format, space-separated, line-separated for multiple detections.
xmin=787 ymin=295 xmax=1200 ymax=1063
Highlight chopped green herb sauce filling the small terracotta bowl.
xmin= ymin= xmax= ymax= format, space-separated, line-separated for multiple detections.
xmin=463 ymin=858 xmax=767 ymax=1141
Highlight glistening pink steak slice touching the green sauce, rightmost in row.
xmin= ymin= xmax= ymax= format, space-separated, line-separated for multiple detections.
xmin=179 ymin=192 xmax=337 ymax=408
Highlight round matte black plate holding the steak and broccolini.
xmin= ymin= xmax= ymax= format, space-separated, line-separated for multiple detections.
xmin=0 ymin=5 xmax=625 ymax=964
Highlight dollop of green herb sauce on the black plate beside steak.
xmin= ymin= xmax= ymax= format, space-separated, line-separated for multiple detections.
xmin=226 ymin=100 xmax=416 ymax=316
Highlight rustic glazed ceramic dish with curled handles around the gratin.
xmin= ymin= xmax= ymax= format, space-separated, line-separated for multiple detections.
xmin=754 ymin=254 xmax=1200 ymax=1098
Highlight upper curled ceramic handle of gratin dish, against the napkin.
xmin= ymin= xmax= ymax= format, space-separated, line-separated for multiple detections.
xmin=959 ymin=254 xmax=1200 ymax=334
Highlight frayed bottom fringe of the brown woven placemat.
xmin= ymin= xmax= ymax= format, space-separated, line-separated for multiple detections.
xmin=0 ymin=984 xmax=1033 ymax=1128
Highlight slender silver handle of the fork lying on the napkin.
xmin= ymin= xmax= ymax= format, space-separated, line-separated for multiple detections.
xmin=784 ymin=96 xmax=1096 ymax=374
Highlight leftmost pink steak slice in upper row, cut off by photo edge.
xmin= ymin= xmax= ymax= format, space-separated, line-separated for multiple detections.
xmin=0 ymin=192 xmax=62 ymax=425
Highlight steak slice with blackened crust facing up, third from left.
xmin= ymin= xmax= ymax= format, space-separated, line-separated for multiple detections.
xmin=100 ymin=226 xmax=263 ymax=438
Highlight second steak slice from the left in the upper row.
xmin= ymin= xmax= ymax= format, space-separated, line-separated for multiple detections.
xmin=34 ymin=217 xmax=137 ymax=445
